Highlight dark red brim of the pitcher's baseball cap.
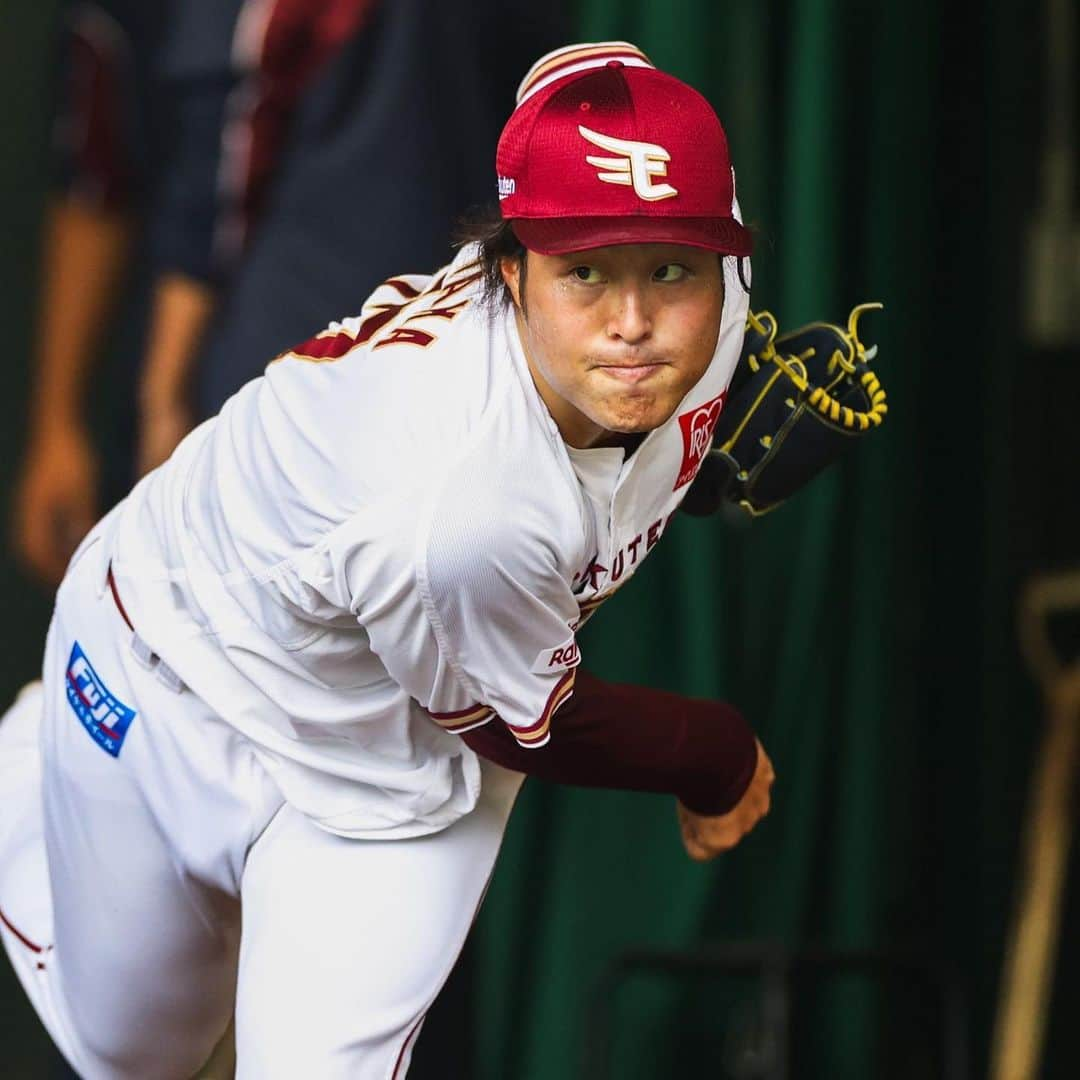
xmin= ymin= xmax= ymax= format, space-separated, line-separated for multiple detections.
xmin=511 ymin=217 xmax=754 ymax=255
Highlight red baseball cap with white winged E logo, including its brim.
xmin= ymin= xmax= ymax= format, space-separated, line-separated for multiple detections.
xmin=496 ymin=41 xmax=753 ymax=255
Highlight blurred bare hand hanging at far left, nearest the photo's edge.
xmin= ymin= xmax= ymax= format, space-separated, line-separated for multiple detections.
xmin=13 ymin=423 xmax=98 ymax=585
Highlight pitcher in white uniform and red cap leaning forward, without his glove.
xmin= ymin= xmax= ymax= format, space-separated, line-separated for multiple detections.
xmin=0 ymin=42 xmax=772 ymax=1080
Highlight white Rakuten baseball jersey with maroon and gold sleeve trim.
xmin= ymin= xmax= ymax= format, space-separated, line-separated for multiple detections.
xmin=101 ymin=247 xmax=747 ymax=837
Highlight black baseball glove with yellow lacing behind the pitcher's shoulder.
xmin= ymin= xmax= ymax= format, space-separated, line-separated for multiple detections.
xmin=681 ymin=303 xmax=888 ymax=517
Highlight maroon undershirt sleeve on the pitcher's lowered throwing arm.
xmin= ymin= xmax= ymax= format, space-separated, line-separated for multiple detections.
xmin=461 ymin=667 xmax=757 ymax=814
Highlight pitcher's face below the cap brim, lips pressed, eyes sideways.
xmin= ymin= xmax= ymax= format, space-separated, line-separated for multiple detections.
xmin=502 ymin=244 xmax=724 ymax=447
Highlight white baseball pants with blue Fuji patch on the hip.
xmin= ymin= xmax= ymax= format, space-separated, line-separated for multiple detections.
xmin=0 ymin=527 xmax=522 ymax=1080
